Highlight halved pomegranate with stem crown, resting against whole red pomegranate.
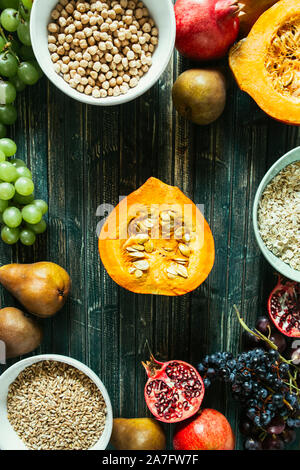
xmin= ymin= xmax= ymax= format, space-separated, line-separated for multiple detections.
xmin=143 ymin=355 xmax=204 ymax=423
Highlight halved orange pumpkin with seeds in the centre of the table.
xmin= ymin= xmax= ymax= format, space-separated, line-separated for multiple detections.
xmin=99 ymin=178 xmax=215 ymax=296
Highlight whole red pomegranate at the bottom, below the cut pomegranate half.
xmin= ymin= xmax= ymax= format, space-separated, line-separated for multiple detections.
xmin=173 ymin=408 xmax=235 ymax=450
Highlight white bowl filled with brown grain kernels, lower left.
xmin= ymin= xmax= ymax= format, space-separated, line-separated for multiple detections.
xmin=0 ymin=354 xmax=113 ymax=450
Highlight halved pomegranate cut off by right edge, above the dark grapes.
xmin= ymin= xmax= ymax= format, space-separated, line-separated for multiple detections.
xmin=268 ymin=276 xmax=300 ymax=338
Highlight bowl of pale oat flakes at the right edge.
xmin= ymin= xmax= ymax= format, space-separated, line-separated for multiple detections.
xmin=253 ymin=147 xmax=300 ymax=282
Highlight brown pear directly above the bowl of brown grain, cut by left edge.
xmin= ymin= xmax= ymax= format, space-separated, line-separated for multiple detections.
xmin=0 ymin=307 xmax=43 ymax=358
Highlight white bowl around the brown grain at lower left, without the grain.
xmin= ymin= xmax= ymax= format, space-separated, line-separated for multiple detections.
xmin=0 ymin=354 xmax=113 ymax=450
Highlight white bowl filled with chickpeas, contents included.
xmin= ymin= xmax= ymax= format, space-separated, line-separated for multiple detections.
xmin=30 ymin=0 xmax=176 ymax=106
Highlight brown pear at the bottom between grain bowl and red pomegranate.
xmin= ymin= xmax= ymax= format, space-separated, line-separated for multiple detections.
xmin=111 ymin=418 xmax=166 ymax=450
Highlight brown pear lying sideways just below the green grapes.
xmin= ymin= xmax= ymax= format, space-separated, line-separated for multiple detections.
xmin=0 ymin=261 xmax=71 ymax=318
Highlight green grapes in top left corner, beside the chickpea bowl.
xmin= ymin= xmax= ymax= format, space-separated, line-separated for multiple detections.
xmin=0 ymin=0 xmax=43 ymax=138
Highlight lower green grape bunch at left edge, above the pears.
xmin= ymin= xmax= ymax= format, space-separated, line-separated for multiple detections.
xmin=0 ymin=138 xmax=48 ymax=246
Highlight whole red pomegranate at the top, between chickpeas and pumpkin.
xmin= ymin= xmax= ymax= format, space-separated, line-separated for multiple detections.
xmin=175 ymin=0 xmax=239 ymax=60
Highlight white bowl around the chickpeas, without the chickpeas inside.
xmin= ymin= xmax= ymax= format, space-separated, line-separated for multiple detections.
xmin=30 ymin=0 xmax=176 ymax=106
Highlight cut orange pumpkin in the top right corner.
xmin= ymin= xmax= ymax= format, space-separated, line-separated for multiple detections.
xmin=229 ymin=0 xmax=300 ymax=125
